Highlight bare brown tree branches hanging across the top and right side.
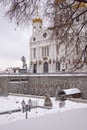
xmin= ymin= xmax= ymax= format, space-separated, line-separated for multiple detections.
xmin=0 ymin=0 xmax=87 ymax=70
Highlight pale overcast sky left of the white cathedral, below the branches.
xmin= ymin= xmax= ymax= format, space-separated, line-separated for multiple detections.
xmin=0 ymin=13 xmax=32 ymax=70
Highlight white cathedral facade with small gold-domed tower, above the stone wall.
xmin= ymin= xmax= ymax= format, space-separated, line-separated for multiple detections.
xmin=29 ymin=14 xmax=85 ymax=73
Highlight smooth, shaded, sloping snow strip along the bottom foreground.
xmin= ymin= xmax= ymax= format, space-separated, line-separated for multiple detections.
xmin=0 ymin=108 xmax=87 ymax=130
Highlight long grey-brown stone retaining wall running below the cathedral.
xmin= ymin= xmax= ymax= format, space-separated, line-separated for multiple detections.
xmin=0 ymin=74 xmax=87 ymax=98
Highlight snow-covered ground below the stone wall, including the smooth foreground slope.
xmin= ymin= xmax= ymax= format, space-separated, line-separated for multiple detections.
xmin=0 ymin=96 xmax=87 ymax=130
